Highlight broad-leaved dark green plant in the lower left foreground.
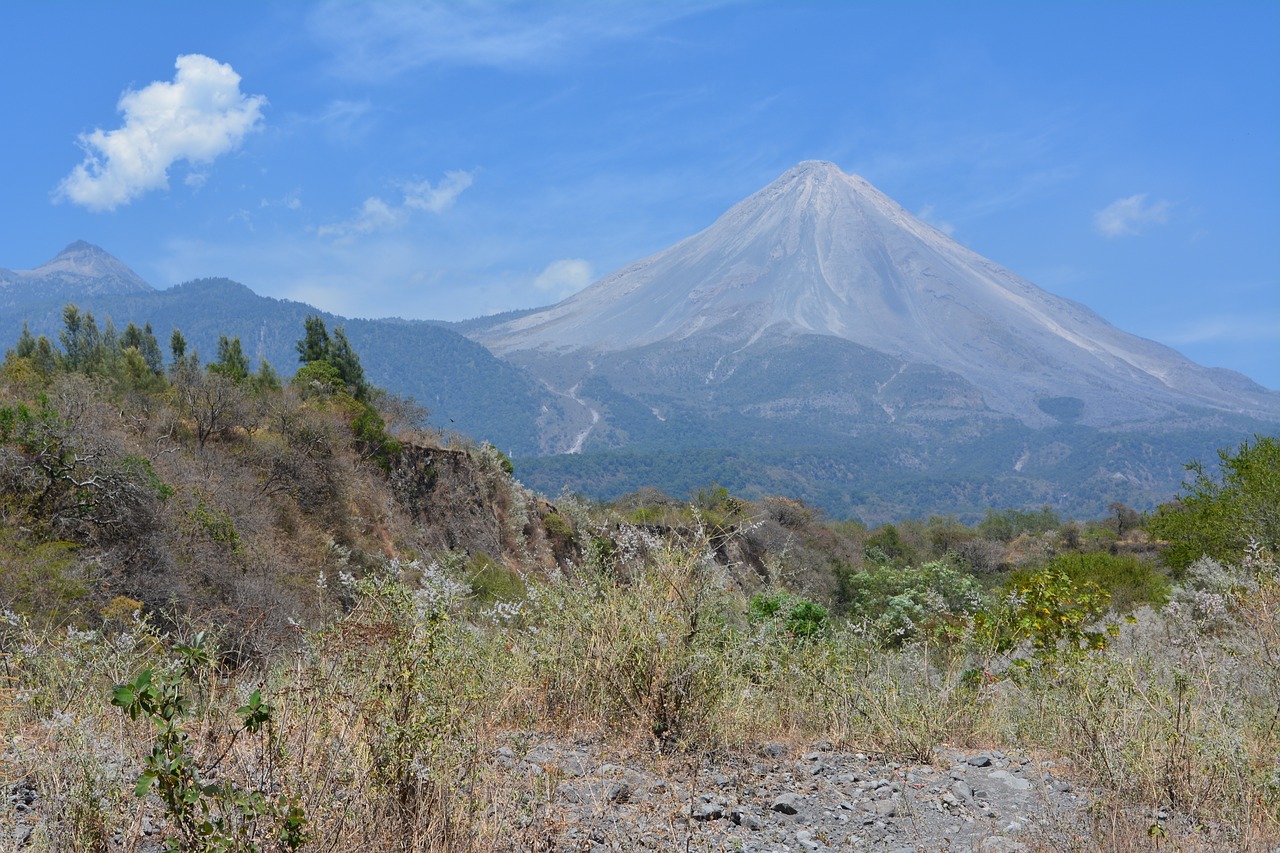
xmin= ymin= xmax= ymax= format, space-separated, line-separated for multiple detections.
xmin=111 ymin=633 xmax=311 ymax=853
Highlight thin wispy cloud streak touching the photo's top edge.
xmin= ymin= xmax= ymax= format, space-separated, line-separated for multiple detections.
xmin=308 ymin=0 xmax=730 ymax=79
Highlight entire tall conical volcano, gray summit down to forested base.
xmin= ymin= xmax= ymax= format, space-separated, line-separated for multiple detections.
xmin=460 ymin=161 xmax=1280 ymax=520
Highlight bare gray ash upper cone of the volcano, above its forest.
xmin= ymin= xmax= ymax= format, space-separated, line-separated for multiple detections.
xmin=471 ymin=161 xmax=1280 ymax=427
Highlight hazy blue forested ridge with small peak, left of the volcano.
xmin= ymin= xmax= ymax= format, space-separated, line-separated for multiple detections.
xmin=0 ymin=242 xmax=581 ymax=455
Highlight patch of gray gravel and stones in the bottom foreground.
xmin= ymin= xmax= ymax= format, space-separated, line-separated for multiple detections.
xmin=498 ymin=742 xmax=1089 ymax=853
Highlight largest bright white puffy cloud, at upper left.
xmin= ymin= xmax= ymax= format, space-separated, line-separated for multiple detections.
xmin=55 ymin=54 xmax=266 ymax=210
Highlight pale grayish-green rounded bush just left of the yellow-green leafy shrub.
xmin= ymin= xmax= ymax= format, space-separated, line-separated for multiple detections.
xmin=838 ymin=560 xmax=983 ymax=646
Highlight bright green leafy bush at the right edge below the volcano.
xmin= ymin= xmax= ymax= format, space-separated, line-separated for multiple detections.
xmin=1147 ymin=435 xmax=1280 ymax=571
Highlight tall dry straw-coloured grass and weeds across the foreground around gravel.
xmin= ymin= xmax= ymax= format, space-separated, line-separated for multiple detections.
xmin=0 ymin=534 xmax=1280 ymax=853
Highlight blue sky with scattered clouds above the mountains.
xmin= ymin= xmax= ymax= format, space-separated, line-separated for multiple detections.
xmin=0 ymin=0 xmax=1280 ymax=388
